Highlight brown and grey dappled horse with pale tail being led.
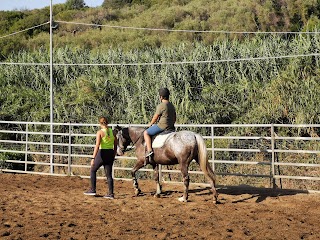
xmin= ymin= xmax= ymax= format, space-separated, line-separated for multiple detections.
xmin=116 ymin=126 xmax=218 ymax=203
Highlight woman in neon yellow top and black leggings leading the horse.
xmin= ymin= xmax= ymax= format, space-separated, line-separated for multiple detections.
xmin=84 ymin=117 xmax=117 ymax=199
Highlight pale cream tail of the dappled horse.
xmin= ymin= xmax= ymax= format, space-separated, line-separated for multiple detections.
xmin=195 ymin=134 xmax=215 ymax=187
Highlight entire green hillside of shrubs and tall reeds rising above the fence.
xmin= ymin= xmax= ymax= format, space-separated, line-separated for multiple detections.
xmin=0 ymin=0 xmax=320 ymax=126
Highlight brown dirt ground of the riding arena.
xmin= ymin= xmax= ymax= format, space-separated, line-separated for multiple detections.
xmin=0 ymin=173 xmax=320 ymax=240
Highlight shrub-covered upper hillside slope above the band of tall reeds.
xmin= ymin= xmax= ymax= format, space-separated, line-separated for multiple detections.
xmin=0 ymin=0 xmax=320 ymax=58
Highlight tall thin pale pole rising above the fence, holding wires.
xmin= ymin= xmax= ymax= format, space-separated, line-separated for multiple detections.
xmin=50 ymin=0 xmax=53 ymax=174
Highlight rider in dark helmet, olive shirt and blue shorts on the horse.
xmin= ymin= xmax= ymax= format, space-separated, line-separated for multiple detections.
xmin=143 ymin=88 xmax=176 ymax=157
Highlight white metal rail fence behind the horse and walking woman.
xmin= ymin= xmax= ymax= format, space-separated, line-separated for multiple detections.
xmin=0 ymin=121 xmax=320 ymax=192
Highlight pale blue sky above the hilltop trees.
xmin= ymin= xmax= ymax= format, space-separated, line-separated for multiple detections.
xmin=0 ymin=0 xmax=103 ymax=11
